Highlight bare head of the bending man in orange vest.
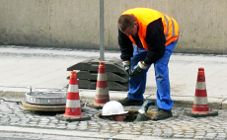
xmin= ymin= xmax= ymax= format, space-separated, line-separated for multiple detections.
xmin=118 ymin=14 xmax=138 ymax=36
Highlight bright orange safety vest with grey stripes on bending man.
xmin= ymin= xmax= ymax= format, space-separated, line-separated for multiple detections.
xmin=122 ymin=8 xmax=179 ymax=50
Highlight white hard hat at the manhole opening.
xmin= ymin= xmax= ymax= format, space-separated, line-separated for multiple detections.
xmin=102 ymin=101 xmax=128 ymax=116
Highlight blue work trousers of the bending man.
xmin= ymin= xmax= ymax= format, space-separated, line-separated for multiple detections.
xmin=128 ymin=41 xmax=177 ymax=111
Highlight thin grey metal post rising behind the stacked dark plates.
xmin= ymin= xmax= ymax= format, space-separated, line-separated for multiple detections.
xmin=100 ymin=0 xmax=104 ymax=61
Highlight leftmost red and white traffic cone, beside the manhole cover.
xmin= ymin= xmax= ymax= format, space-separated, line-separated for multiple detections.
xmin=56 ymin=71 xmax=91 ymax=121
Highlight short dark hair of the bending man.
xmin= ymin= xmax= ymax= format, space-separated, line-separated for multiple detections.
xmin=118 ymin=14 xmax=136 ymax=31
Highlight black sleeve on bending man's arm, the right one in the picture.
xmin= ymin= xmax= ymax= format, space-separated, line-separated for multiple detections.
xmin=144 ymin=18 xmax=166 ymax=64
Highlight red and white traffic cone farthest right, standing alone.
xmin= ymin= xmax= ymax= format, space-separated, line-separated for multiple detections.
xmin=186 ymin=68 xmax=218 ymax=117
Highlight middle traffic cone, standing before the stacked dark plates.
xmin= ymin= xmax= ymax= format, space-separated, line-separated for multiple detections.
xmin=94 ymin=62 xmax=110 ymax=106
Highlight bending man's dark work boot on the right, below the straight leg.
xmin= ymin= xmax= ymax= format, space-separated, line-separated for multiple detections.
xmin=151 ymin=109 xmax=173 ymax=121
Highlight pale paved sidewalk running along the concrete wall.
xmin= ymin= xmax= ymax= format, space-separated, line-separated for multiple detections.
xmin=0 ymin=46 xmax=227 ymax=109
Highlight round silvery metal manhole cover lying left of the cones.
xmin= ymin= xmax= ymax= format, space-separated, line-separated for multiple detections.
xmin=25 ymin=91 xmax=67 ymax=105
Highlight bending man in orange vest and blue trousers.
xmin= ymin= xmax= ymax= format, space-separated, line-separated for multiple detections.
xmin=118 ymin=8 xmax=179 ymax=120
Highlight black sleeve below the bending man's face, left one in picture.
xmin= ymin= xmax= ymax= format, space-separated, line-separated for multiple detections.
xmin=118 ymin=29 xmax=133 ymax=61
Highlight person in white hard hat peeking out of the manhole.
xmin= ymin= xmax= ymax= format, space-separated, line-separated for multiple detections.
xmin=102 ymin=101 xmax=128 ymax=122
